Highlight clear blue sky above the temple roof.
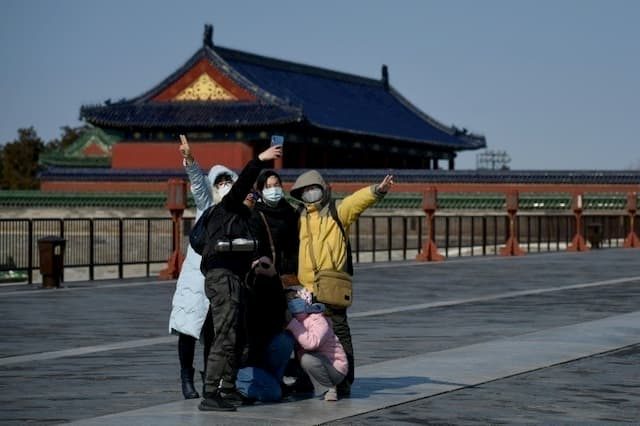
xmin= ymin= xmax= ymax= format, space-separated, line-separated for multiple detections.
xmin=0 ymin=0 xmax=640 ymax=170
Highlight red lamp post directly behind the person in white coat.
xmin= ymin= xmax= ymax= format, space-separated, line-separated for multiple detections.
xmin=159 ymin=179 xmax=187 ymax=280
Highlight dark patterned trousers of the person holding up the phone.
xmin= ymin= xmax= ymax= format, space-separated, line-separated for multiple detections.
xmin=204 ymin=269 xmax=245 ymax=392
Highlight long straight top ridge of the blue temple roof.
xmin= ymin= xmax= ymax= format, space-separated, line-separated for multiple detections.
xmin=215 ymin=46 xmax=384 ymax=89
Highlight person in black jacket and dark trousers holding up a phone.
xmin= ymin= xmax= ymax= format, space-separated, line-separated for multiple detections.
xmin=198 ymin=146 xmax=282 ymax=411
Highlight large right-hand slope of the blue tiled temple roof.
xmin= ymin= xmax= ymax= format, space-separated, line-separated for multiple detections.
xmin=216 ymin=47 xmax=485 ymax=149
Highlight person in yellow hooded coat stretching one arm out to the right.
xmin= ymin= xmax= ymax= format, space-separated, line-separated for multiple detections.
xmin=290 ymin=170 xmax=393 ymax=397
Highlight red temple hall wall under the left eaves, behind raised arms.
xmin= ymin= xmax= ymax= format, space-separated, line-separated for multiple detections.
xmin=111 ymin=142 xmax=254 ymax=170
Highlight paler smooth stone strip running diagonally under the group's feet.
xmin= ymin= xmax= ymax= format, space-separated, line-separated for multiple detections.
xmin=72 ymin=311 xmax=640 ymax=426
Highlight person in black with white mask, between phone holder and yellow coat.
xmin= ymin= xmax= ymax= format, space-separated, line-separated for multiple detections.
xmin=236 ymin=170 xmax=299 ymax=402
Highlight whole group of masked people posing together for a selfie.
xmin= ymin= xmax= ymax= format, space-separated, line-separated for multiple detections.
xmin=169 ymin=135 xmax=393 ymax=411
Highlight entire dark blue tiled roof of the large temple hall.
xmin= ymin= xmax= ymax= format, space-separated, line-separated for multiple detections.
xmin=80 ymin=45 xmax=486 ymax=150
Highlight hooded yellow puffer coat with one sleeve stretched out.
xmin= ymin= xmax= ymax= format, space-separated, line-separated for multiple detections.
xmin=291 ymin=170 xmax=384 ymax=291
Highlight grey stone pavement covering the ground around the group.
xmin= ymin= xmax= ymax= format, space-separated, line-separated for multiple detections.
xmin=0 ymin=249 xmax=640 ymax=425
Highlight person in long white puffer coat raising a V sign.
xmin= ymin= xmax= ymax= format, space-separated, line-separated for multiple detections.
xmin=169 ymin=135 xmax=238 ymax=399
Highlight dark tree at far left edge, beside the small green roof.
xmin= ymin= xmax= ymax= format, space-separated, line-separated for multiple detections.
xmin=0 ymin=127 xmax=44 ymax=189
